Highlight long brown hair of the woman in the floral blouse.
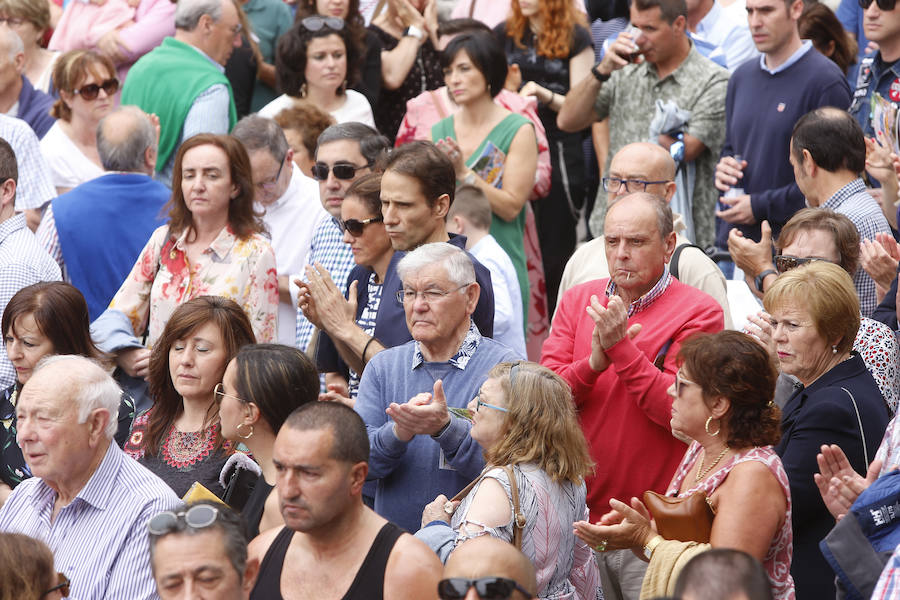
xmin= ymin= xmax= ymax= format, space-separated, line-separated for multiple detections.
xmin=166 ymin=133 xmax=266 ymax=240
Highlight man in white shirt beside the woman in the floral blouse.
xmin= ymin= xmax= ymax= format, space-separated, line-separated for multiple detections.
xmin=231 ymin=115 xmax=326 ymax=346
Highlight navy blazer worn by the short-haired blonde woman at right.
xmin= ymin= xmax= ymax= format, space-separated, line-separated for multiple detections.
xmin=775 ymin=354 xmax=890 ymax=600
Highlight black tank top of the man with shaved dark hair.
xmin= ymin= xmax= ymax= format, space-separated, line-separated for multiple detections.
xmin=250 ymin=521 xmax=405 ymax=600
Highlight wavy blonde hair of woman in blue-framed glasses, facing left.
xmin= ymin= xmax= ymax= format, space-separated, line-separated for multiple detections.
xmin=484 ymin=361 xmax=593 ymax=484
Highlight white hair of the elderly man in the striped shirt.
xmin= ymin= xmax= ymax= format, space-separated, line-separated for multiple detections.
xmin=34 ymin=354 xmax=122 ymax=440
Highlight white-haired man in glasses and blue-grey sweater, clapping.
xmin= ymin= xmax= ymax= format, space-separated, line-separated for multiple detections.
xmin=355 ymin=242 xmax=518 ymax=531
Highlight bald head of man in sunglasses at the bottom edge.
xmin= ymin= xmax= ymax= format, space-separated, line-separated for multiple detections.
xmin=444 ymin=535 xmax=537 ymax=599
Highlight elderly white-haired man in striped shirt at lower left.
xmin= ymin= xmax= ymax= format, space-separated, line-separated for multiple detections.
xmin=0 ymin=356 xmax=179 ymax=600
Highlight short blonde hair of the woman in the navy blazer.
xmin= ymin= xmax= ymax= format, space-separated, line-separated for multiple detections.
xmin=763 ymin=260 xmax=859 ymax=352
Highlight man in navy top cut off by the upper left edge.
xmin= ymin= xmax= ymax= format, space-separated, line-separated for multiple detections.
xmin=0 ymin=27 xmax=56 ymax=138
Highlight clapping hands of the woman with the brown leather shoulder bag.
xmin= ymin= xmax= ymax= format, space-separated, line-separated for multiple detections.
xmin=574 ymin=498 xmax=657 ymax=552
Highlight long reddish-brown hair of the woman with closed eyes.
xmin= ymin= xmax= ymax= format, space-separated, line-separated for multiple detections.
xmin=143 ymin=296 xmax=256 ymax=455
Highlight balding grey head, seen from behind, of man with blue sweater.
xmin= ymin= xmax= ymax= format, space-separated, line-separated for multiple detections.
xmin=97 ymin=106 xmax=156 ymax=173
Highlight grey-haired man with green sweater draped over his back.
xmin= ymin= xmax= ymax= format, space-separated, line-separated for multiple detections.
xmin=122 ymin=0 xmax=242 ymax=187
